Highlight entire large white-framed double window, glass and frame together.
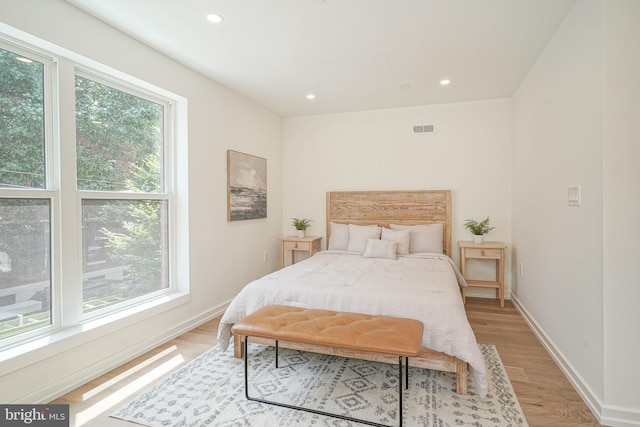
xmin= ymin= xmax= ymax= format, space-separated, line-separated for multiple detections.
xmin=0 ymin=37 xmax=185 ymax=349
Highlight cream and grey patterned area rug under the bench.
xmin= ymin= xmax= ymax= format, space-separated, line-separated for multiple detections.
xmin=111 ymin=344 xmax=527 ymax=427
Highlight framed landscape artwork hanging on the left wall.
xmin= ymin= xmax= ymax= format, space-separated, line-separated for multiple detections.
xmin=227 ymin=150 xmax=267 ymax=221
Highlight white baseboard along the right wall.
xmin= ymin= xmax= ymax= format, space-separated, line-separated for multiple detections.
xmin=510 ymin=293 xmax=640 ymax=427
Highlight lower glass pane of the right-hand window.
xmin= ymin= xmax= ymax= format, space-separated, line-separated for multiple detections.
xmin=82 ymin=199 xmax=169 ymax=313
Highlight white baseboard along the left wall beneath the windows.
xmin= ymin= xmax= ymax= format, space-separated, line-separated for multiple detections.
xmin=29 ymin=301 xmax=230 ymax=404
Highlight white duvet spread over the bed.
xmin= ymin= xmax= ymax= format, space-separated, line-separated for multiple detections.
xmin=218 ymin=251 xmax=487 ymax=396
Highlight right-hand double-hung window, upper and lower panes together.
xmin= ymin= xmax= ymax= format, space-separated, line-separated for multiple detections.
xmin=75 ymin=75 xmax=170 ymax=313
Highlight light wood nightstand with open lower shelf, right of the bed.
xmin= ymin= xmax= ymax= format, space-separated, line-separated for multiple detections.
xmin=458 ymin=241 xmax=506 ymax=307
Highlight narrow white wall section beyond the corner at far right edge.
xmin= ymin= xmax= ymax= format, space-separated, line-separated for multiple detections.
xmin=603 ymin=0 xmax=640 ymax=425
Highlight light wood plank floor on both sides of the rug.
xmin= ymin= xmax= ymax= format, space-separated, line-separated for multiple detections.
xmin=52 ymin=298 xmax=600 ymax=427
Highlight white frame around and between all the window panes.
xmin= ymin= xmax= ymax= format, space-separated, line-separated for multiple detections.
xmin=0 ymin=23 xmax=190 ymax=358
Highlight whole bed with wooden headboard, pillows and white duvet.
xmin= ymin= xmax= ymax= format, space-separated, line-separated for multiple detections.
xmin=218 ymin=190 xmax=487 ymax=396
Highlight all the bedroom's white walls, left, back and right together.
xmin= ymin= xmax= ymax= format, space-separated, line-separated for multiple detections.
xmin=0 ymin=0 xmax=640 ymax=425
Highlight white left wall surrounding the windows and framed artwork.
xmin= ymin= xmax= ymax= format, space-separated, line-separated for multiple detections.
xmin=0 ymin=0 xmax=282 ymax=403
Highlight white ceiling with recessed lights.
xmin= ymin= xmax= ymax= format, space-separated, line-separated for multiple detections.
xmin=67 ymin=0 xmax=575 ymax=117
